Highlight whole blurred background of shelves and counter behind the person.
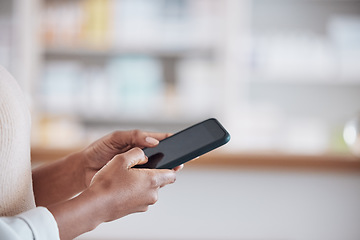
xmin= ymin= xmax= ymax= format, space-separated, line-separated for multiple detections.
xmin=0 ymin=0 xmax=360 ymax=239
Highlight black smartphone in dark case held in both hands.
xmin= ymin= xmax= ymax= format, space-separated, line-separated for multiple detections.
xmin=135 ymin=118 xmax=230 ymax=169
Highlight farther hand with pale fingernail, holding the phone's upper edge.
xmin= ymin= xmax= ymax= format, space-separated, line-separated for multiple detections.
xmin=83 ymin=130 xmax=172 ymax=187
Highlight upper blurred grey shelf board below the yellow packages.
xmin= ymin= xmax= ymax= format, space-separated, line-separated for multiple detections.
xmin=43 ymin=47 xmax=214 ymax=58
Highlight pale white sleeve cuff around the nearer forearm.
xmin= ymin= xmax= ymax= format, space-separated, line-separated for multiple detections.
xmin=0 ymin=207 xmax=60 ymax=240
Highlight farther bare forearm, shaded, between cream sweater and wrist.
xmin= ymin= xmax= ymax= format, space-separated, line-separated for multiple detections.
xmin=32 ymin=152 xmax=86 ymax=206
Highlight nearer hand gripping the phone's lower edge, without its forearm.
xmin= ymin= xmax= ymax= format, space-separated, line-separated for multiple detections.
xmin=89 ymin=148 xmax=177 ymax=221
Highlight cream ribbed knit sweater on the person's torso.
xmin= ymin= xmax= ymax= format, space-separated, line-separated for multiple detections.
xmin=0 ymin=66 xmax=35 ymax=216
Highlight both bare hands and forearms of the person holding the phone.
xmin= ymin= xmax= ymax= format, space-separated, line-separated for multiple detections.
xmin=33 ymin=130 xmax=182 ymax=240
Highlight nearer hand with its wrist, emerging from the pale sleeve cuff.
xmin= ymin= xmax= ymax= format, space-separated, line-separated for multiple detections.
xmin=48 ymin=147 xmax=182 ymax=240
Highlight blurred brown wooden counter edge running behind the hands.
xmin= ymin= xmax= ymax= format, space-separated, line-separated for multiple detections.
xmin=31 ymin=147 xmax=360 ymax=173
